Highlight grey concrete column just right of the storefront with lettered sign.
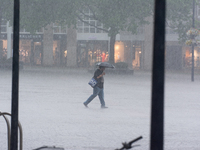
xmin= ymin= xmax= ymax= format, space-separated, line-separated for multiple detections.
xmin=43 ymin=24 xmax=53 ymax=66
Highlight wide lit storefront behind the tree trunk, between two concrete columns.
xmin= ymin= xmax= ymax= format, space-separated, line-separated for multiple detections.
xmin=77 ymin=40 xmax=142 ymax=68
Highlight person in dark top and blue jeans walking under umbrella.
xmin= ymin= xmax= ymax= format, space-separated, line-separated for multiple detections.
xmin=83 ymin=66 xmax=108 ymax=108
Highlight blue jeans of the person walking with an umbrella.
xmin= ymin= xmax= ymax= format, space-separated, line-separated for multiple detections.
xmin=84 ymin=86 xmax=105 ymax=107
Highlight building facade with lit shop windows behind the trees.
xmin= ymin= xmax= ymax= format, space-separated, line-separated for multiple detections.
xmin=1 ymin=15 xmax=200 ymax=70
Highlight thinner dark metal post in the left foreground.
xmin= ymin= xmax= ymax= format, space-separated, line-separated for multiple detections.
xmin=11 ymin=0 xmax=20 ymax=150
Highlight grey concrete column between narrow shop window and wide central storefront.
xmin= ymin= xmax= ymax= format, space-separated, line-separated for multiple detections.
xmin=67 ymin=27 xmax=77 ymax=67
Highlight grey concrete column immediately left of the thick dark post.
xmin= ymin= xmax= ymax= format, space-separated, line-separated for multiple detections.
xmin=143 ymin=16 xmax=153 ymax=70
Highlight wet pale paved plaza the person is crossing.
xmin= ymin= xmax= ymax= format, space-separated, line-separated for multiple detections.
xmin=0 ymin=68 xmax=200 ymax=150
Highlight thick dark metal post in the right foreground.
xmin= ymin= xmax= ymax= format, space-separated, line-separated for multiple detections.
xmin=150 ymin=0 xmax=166 ymax=150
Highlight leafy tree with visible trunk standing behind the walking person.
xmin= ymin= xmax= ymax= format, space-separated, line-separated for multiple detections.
xmin=53 ymin=0 xmax=153 ymax=63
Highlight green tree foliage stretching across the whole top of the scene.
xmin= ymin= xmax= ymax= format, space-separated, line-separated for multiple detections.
xmin=0 ymin=0 xmax=200 ymax=44
